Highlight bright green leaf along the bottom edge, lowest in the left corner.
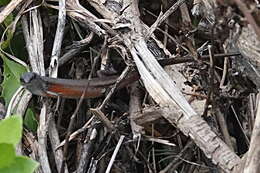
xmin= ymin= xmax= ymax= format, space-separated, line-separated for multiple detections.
xmin=0 ymin=156 xmax=39 ymax=173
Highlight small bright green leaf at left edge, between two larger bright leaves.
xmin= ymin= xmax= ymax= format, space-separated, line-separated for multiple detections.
xmin=0 ymin=143 xmax=15 ymax=168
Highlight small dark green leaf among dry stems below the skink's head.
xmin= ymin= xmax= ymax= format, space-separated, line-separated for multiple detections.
xmin=24 ymin=108 xmax=38 ymax=132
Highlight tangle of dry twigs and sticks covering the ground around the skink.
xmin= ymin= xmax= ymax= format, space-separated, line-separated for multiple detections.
xmin=0 ymin=0 xmax=260 ymax=173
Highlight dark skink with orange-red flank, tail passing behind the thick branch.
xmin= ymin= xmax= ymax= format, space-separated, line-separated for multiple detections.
xmin=20 ymin=53 xmax=238 ymax=99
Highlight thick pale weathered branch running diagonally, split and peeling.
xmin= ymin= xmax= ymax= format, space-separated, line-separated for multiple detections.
xmin=85 ymin=0 xmax=240 ymax=172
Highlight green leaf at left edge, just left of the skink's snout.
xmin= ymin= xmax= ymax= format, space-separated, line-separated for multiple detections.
xmin=1 ymin=54 xmax=26 ymax=105
